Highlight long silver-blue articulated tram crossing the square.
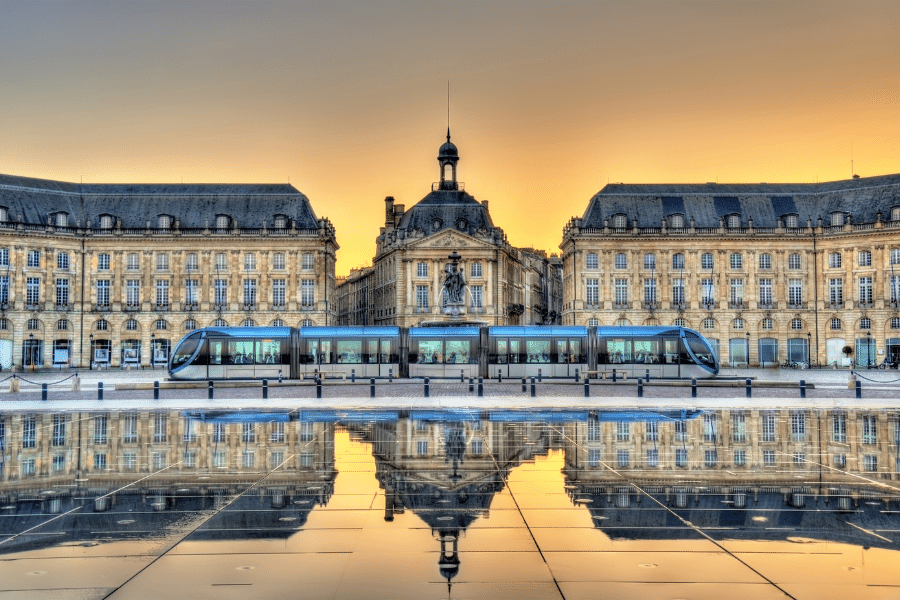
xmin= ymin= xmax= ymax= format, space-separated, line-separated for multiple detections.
xmin=169 ymin=326 xmax=719 ymax=380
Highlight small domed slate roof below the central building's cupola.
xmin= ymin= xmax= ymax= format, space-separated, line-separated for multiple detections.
xmin=398 ymin=190 xmax=494 ymax=235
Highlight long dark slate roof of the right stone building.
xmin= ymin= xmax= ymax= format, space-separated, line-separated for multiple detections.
xmin=581 ymin=174 xmax=900 ymax=228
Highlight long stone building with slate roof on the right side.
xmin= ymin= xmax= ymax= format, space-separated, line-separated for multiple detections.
xmin=560 ymin=175 xmax=900 ymax=365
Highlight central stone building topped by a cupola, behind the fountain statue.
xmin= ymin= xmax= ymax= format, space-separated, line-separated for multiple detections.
xmin=337 ymin=130 xmax=561 ymax=327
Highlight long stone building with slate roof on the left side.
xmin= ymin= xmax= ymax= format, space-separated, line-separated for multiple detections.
xmin=0 ymin=175 xmax=338 ymax=368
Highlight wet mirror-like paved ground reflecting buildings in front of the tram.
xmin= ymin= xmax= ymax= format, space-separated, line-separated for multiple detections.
xmin=0 ymin=371 xmax=900 ymax=600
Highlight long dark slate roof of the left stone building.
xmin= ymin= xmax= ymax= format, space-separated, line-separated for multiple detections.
xmin=0 ymin=174 xmax=318 ymax=229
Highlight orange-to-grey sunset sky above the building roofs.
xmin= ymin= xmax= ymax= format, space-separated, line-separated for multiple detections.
xmin=0 ymin=0 xmax=900 ymax=274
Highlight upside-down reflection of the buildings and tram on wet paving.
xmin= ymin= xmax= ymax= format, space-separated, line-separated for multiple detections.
xmin=0 ymin=409 xmax=900 ymax=585
